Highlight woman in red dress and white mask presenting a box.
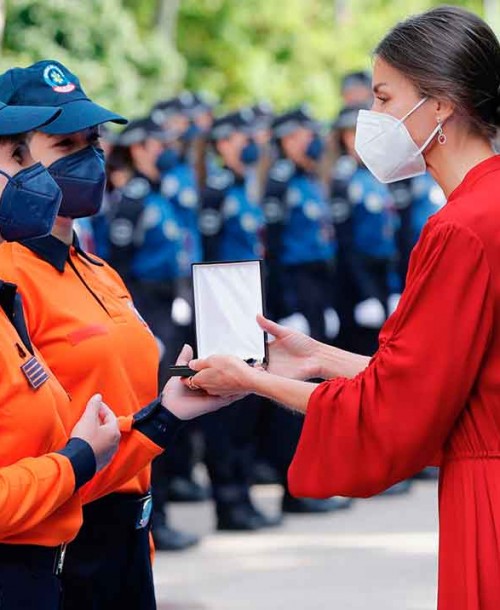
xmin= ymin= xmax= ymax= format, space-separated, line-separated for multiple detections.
xmin=186 ymin=7 xmax=500 ymax=610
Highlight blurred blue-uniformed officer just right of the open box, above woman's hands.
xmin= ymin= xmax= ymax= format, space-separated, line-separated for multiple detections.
xmin=264 ymin=108 xmax=335 ymax=341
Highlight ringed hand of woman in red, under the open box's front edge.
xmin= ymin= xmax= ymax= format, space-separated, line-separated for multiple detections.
xmin=185 ymin=356 xmax=260 ymax=397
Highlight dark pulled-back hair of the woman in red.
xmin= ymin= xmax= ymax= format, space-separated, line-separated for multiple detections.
xmin=375 ymin=6 xmax=500 ymax=138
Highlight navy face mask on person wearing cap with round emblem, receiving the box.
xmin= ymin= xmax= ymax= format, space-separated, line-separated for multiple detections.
xmin=47 ymin=146 xmax=106 ymax=218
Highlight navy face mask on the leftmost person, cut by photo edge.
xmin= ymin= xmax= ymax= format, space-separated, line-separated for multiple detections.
xmin=0 ymin=163 xmax=62 ymax=241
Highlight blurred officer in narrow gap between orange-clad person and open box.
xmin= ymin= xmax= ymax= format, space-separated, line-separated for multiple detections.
xmin=151 ymin=91 xmax=210 ymax=502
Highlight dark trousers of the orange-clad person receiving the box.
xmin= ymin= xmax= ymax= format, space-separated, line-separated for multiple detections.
xmin=60 ymin=493 xmax=156 ymax=610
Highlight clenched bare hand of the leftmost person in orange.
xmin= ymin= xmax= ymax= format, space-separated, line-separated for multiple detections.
xmin=70 ymin=394 xmax=120 ymax=472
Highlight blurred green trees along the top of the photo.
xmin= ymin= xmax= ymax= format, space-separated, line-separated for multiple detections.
xmin=0 ymin=0 xmax=488 ymax=117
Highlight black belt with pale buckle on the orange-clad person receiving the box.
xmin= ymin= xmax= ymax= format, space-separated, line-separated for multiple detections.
xmin=83 ymin=486 xmax=152 ymax=529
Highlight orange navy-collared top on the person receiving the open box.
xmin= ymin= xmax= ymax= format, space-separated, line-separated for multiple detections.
xmin=0 ymin=236 xmax=175 ymax=503
